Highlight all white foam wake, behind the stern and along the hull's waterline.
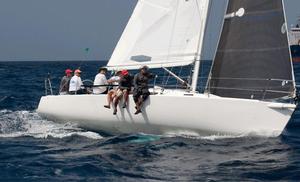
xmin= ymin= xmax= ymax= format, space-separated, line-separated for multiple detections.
xmin=0 ymin=110 xmax=277 ymax=143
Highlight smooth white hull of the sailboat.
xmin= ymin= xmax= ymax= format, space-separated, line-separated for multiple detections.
xmin=37 ymin=92 xmax=296 ymax=135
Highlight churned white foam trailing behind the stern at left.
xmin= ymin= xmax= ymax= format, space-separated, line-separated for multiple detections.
xmin=0 ymin=110 xmax=103 ymax=140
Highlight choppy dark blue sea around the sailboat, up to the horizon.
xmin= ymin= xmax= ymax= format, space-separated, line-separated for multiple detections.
xmin=0 ymin=61 xmax=300 ymax=181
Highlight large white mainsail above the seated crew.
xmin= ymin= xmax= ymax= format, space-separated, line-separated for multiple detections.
xmin=107 ymin=0 xmax=209 ymax=69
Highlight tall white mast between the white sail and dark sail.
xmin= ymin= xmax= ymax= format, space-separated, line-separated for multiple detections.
xmin=191 ymin=0 xmax=210 ymax=92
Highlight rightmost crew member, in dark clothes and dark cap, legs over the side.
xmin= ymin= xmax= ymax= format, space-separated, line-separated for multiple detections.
xmin=133 ymin=66 xmax=155 ymax=114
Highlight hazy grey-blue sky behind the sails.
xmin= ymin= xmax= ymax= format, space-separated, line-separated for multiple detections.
xmin=0 ymin=0 xmax=300 ymax=61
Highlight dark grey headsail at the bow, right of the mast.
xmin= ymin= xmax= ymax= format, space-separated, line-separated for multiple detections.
xmin=207 ymin=0 xmax=295 ymax=99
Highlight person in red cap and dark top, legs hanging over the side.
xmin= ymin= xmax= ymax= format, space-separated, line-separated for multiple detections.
xmin=113 ymin=70 xmax=132 ymax=115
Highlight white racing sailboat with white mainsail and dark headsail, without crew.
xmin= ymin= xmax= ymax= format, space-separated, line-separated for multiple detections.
xmin=37 ymin=0 xmax=296 ymax=136
